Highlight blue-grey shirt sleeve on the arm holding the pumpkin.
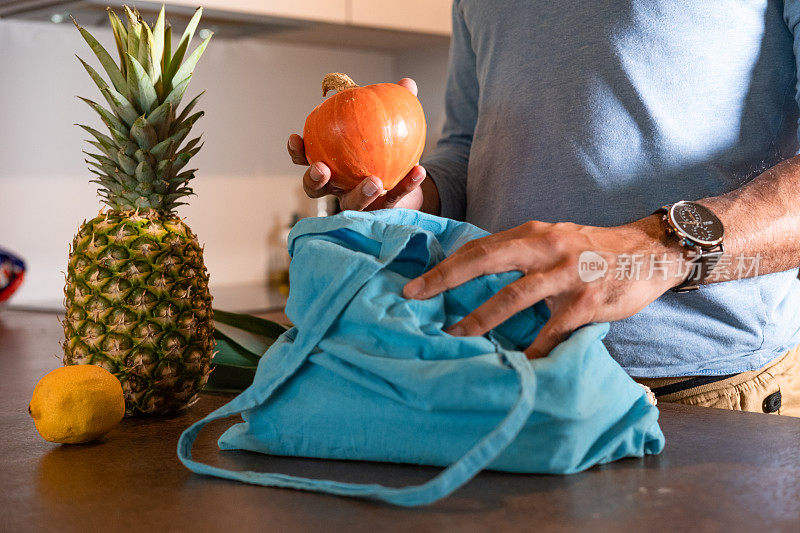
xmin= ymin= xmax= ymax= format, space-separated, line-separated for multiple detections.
xmin=422 ymin=0 xmax=479 ymax=220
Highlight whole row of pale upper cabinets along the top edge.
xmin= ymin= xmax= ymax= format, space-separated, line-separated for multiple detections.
xmin=7 ymin=0 xmax=452 ymax=39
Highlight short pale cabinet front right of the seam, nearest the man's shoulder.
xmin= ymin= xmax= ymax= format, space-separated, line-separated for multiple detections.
xmin=347 ymin=0 xmax=452 ymax=35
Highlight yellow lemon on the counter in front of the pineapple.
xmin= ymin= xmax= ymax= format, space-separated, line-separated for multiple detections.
xmin=28 ymin=365 xmax=125 ymax=444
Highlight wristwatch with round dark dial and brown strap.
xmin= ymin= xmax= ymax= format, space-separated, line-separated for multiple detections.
xmin=656 ymin=201 xmax=725 ymax=292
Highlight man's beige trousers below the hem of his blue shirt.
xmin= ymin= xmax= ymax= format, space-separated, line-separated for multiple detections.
xmin=634 ymin=345 xmax=800 ymax=417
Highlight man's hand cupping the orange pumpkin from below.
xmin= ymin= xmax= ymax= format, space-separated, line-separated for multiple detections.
xmin=287 ymin=78 xmax=425 ymax=211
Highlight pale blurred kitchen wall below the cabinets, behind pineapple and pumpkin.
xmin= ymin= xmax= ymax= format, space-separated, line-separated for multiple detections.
xmin=0 ymin=20 xmax=446 ymax=305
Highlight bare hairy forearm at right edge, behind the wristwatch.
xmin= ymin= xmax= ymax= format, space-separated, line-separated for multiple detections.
xmin=698 ymin=156 xmax=800 ymax=282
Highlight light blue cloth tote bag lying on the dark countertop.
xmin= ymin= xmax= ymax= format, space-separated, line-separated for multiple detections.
xmin=178 ymin=209 xmax=664 ymax=506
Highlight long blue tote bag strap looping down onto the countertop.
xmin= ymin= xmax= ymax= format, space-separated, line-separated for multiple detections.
xmin=178 ymin=225 xmax=536 ymax=507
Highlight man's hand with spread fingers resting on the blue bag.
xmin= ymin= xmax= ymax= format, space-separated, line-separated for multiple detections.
xmin=403 ymin=215 xmax=689 ymax=358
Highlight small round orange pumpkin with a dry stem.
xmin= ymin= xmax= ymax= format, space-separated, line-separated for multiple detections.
xmin=303 ymin=72 xmax=425 ymax=191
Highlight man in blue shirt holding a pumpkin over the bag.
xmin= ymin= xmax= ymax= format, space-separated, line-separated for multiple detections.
xmin=289 ymin=0 xmax=800 ymax=416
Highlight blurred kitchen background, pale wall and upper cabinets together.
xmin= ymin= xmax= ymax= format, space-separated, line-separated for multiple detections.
xmin=0 ymin=0 xmax=450 ymax=308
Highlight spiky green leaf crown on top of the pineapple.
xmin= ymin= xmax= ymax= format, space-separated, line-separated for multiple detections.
xmin=73 ymin=6 xmax=211 ymax=215
